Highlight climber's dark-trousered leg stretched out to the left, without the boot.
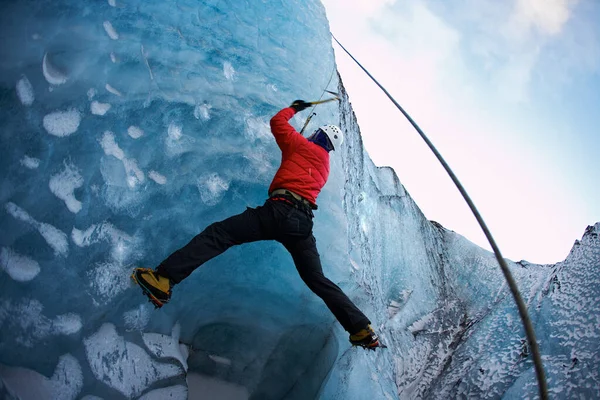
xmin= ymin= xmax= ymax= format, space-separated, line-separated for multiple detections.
xmin=156 ymin=206 xmax=272 ymax=284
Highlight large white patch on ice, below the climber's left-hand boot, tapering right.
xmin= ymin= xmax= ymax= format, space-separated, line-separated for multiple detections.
xmin=83 ymin=323 xmax=183 ymax=398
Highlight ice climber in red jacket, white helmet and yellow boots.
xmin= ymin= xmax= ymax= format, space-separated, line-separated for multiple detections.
xmin=132 ymin=100 xmax=381 ymax=349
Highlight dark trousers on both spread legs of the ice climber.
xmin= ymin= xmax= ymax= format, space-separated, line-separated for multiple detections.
xmin=157 ymin=199 xmax=370 ymax=334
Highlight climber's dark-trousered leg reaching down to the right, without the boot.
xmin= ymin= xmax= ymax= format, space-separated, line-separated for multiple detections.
xmin=283 ymin=234 xmax=371 ymax=334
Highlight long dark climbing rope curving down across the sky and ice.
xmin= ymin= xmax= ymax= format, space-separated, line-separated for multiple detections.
xmin=331 ymin=34 xmax=548 ymax=400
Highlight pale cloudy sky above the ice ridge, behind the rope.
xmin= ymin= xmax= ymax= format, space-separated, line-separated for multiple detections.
xmin=322 ymin=0 xmax=600 ymax=264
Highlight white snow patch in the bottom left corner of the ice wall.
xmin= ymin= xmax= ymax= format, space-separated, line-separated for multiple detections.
xmin=0 ymin=354 xmax=83 ymax=400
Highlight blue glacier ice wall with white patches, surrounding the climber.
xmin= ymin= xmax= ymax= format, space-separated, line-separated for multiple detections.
xmin=0 ymin=0 xmax=600 ymax=400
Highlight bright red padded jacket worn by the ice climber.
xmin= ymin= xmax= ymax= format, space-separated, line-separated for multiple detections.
xmin=269 ymin=107 xmax=329 ymax=204
